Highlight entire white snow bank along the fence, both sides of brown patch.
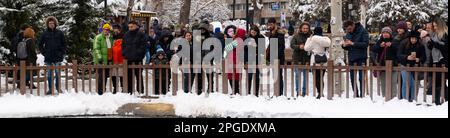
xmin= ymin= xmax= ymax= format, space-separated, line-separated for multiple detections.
xmin=0 ymin=92 xmax=448 ymax=118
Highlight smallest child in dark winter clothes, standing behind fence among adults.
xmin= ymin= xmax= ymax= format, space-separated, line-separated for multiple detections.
xmin=151 ymin=48 xmax=169 ymax=95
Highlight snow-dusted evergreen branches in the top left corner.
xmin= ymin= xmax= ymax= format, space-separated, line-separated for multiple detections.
xmin=0 ymin=0 xmax=71 ymax=65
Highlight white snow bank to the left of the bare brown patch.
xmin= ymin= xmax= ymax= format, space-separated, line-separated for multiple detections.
xmin=0 ymin=93 xmax=145 ymax=118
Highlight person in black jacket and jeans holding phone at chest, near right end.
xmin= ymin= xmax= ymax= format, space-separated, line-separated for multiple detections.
xmin=397 ymin=31 xmax=426 ymax=102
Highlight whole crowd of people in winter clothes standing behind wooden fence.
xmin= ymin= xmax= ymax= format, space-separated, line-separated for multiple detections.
xmin=13 ymin=14 xmax=448 ymax=104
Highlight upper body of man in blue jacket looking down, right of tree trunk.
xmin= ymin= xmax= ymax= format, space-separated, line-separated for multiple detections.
xmin=343 ymin=23 xmax=369 ymax=62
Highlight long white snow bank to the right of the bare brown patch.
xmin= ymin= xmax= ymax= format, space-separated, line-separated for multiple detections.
xmin=152 ymin=92 xmax=448 ymax=118
